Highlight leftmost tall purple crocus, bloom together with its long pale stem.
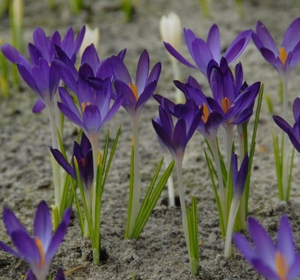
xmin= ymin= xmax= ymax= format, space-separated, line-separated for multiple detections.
xmin=1 ymin=26 xmax=85 ymax=228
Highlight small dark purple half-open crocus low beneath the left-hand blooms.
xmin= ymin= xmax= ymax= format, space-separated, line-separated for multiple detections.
xmin=50 ymin=133 xmax=94 ymax=190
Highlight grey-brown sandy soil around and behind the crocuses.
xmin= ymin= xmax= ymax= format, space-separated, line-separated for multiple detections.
xmin=0 ymin=0 xmax=300 ymax=280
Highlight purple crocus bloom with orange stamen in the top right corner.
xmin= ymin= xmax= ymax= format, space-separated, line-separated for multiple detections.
xmin=252 ymin=18 xmax=300 ymax=78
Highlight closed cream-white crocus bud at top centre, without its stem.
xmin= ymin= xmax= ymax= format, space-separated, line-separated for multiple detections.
xmin=160 ymin=12 xmax=182 ymax=59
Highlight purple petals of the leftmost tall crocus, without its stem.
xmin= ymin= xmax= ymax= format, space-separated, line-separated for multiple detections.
xmin=1 ymin=26 xmax=85 ymax=113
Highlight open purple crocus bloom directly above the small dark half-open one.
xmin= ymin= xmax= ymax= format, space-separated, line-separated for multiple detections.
xmin=58 ymin=73 xmax=123 ymax=146
